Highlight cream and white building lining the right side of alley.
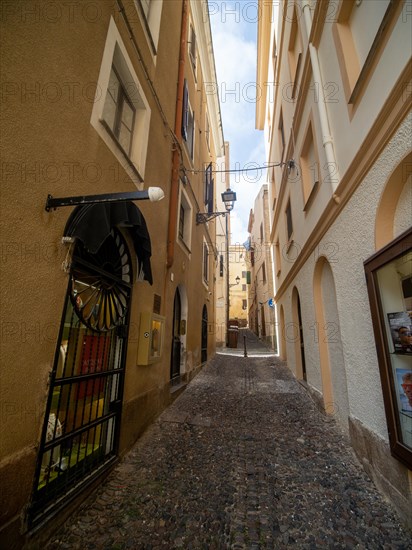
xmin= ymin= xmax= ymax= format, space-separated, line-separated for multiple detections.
xmin=256 ymin=0 xmax=412 ymax=524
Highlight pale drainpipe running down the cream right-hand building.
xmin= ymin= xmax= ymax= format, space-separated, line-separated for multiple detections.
xmin=302 ymin=0 xmax=340 ymax=195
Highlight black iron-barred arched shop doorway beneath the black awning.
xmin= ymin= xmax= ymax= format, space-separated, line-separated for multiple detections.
xmin=29 ymin=229 xmax=132 ymax=524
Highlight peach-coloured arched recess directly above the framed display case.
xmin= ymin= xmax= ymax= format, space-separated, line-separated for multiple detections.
xmin=375 ymin=153 xmax=412 ymax=250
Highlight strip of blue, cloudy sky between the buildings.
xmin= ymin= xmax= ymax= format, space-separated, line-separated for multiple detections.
xmin=209 ymin=0 xmax=266 ymax=244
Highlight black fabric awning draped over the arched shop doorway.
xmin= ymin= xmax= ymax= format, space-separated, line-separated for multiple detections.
xmin=64 ymin=201 xmax=153 ymax=284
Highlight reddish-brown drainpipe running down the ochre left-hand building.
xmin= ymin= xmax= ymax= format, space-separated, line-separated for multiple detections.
xmin=166 ymin=0 xmax=188 ymax=268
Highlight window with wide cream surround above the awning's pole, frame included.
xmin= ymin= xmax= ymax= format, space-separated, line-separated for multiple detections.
xmin=90 ymin=18 xmax=151 ymax=179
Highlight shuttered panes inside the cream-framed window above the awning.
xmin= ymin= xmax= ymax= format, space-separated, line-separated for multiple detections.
xmin=103 ymin=67 xmax=136 ymax=156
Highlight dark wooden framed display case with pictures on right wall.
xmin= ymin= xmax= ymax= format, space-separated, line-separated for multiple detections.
xmin=364 ymin=228 xmax=412 ymax=468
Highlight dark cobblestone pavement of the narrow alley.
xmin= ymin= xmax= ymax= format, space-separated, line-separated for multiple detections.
xmin=48 ymin=338 xmax=412 ymax=550
